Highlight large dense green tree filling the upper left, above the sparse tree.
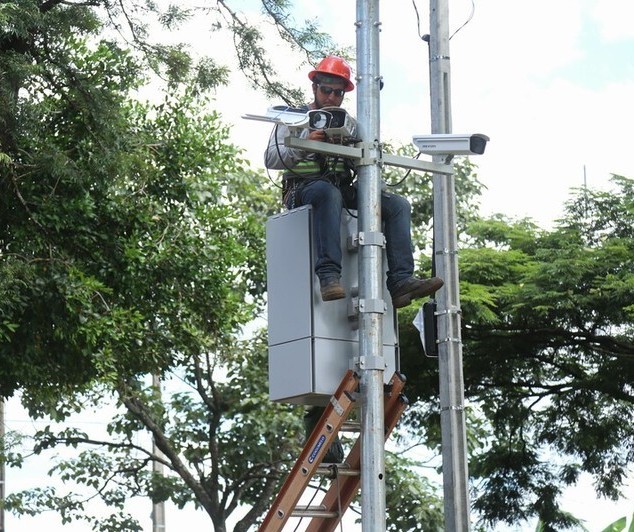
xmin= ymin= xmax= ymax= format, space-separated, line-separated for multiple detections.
xmin=0 ymin=0 xmax=290 ymax=396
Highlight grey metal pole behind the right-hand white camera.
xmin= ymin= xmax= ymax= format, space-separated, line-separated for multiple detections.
xmin=429 ymin=0 xmax=470 ymax=532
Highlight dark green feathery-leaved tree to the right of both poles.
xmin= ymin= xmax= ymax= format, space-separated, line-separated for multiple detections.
xmin=401 ymin=176 xmax=634 ymax=530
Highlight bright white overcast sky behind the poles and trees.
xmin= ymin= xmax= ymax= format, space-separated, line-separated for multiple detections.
xmin=7 ymin=0 xmax=634 ymax=532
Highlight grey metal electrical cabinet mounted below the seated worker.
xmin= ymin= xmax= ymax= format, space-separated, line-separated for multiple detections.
xmin=266 ymin=205 xmax=399 ymax=405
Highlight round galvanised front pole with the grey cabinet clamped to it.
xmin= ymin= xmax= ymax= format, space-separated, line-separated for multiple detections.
xmin=356 ymin=0 xmax=385 ymax=532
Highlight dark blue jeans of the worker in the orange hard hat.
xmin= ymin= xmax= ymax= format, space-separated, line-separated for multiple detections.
xmin=287 ymin=179 xmax=414 ymax=290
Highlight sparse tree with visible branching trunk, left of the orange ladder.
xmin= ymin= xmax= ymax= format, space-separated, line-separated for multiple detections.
xmin=2 ymin=338 xmax=302 ymax=532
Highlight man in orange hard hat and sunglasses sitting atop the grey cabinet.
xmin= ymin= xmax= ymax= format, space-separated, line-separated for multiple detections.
xmin=265 ymin=55 xmax=443 ymax=308
